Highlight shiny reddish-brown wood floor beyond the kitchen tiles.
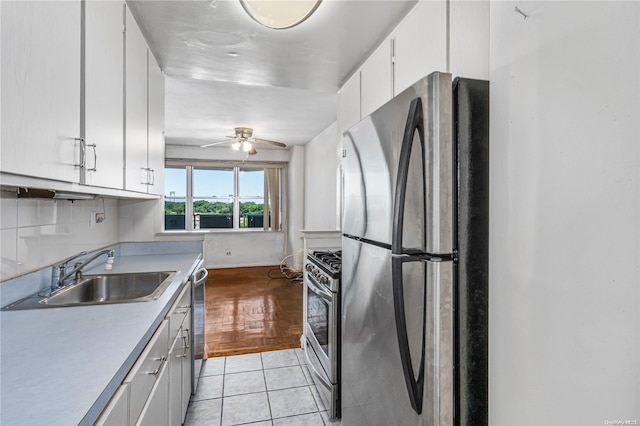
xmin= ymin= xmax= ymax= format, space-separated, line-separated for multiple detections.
xmin=205 ymin=266 xmax=302 ymax=357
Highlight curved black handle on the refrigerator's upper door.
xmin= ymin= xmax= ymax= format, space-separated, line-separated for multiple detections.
xmin=391 ymin=98 xmax=425 ymax=254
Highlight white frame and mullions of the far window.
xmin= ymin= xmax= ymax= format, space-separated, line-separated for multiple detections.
xmin=162 ymin=160 xmax=286 ymax=232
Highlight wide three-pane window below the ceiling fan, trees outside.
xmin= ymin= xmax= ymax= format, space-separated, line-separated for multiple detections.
xmin=165 ymin=161 xmax=283 ymax=231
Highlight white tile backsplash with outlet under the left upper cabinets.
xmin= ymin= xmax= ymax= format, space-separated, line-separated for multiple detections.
xmin=0 ymin=191 xmax=120 ymax=280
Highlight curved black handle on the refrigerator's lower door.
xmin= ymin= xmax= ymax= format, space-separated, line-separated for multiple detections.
xmin=391 ymin=256 xmax=427 ymax=414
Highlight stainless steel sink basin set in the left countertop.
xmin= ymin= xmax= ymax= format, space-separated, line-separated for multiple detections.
xmin=3 ymin=272 xmax=175 ymax=310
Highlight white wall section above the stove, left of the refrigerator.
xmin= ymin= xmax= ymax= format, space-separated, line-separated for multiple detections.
xmin=304 ymin=122 xmax=340 ymax=230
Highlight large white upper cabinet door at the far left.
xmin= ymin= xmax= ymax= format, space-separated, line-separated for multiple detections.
xmin=0 ymin=0 xmax=81 ymax=182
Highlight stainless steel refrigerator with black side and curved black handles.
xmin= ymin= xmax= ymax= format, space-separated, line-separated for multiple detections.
xmin=341 ymin=73 xmax=489 ymax=426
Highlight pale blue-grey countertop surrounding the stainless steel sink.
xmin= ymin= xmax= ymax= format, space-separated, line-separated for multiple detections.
xmin=0 ymin=248 xmax=201 ymax=426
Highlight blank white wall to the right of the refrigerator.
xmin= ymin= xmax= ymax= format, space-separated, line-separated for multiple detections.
xmin=489 ymin=1 xmax=640 ymax=426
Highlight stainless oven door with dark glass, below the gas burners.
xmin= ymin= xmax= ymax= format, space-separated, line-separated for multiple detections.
xmin=305 ymin=274 xmax=338 ymax=383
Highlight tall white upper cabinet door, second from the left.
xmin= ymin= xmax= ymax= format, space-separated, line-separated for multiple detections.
xmin=84 ymin=1 xmax=124 ymax=189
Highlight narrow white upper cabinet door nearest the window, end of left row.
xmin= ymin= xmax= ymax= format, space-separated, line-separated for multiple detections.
xmin=148 ymin=51 xmax=164 ymax=195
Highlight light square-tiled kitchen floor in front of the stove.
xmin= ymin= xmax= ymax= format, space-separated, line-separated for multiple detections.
xmin=184 ymin=349 xmax=341 ymax=426
